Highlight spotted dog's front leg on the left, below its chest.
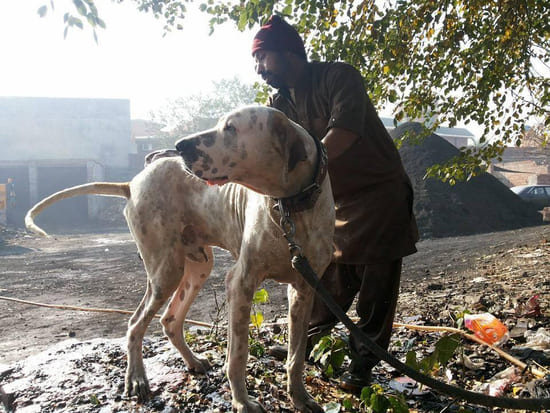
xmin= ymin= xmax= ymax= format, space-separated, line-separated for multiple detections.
xmin=226 ymin=262 xmax=265 ymax=413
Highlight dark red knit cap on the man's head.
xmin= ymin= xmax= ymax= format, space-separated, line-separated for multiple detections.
xmin=252 ymin=15 xmax=307 ymax=60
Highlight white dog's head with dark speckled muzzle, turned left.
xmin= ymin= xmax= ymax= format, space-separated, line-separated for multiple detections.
xmin=176 ymin=106 xmax=315 ymax=197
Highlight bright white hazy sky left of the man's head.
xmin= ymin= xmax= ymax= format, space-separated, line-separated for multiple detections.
xmin=0 ymin=0 xmax=260 ymax=118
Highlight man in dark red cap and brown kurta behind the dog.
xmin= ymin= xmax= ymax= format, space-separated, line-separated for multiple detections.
xmin=252 ymin=16 xmax=418 ymax=391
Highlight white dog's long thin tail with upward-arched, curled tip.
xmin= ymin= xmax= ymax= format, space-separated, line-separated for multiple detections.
xmin=25 ymin=182 xmax=130 ymax=237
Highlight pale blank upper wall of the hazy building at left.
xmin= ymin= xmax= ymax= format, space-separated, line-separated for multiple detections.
xmin=0 ymin=97 xmax=135 ymax=167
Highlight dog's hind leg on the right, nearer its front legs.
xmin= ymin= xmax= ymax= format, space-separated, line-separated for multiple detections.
xmin=161 ymin=247 xmax=214 ymax=373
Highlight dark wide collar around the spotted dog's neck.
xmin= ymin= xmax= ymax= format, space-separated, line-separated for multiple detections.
xmin=274 ymin=138 xmax=328 ymax=212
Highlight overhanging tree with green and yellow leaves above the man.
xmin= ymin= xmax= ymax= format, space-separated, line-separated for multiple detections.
xmin=40 ymin=0 xmax=550 ymax=182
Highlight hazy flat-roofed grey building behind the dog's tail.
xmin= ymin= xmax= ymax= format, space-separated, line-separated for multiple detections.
xmin=0 ymin=97 xmax=136 ymax=226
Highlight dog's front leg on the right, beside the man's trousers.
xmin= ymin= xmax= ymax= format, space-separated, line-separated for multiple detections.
xmin=286 ymin=280 xmax=323 ymax=412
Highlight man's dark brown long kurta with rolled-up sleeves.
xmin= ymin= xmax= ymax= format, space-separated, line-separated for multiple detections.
xmin=271 ymin=62 xmax=418 ymax=264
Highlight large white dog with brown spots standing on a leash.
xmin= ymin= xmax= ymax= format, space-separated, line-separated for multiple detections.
xmin=26 ymin=106 xmax=334 ymax=412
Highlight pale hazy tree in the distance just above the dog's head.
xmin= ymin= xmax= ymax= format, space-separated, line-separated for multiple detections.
xmin=152 ymin=77 xmax=256 ymax=140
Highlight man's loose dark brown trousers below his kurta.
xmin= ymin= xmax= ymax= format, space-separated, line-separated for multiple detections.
xmin=308 ymin=258 xmax=402 ymax=375
